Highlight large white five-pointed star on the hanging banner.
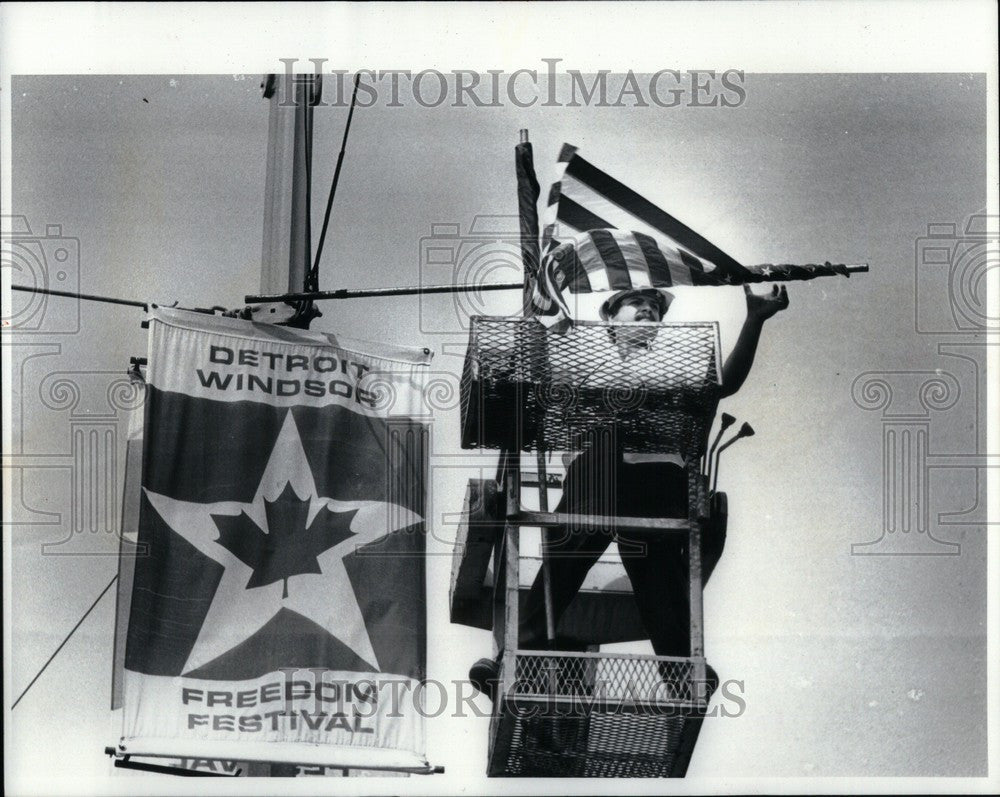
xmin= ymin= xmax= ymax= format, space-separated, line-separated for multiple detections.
xmin=145 ymin=411 xmax=421 ymax=672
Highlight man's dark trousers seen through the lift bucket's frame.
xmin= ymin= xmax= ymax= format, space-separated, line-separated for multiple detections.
xmin=520 ymin=448 xmax=725 ymax=656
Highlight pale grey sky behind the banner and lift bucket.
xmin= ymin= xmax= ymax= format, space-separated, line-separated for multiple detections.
xmin=6 ymin=4 xmax=987 ymax=791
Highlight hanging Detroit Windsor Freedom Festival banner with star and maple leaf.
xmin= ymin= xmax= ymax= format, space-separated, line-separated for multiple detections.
xmin=118 ymin=311 xmax=430 ymax=770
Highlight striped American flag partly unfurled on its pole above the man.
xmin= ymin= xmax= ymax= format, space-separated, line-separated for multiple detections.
xmin=530 ymin=144 xmax=868 ymax=327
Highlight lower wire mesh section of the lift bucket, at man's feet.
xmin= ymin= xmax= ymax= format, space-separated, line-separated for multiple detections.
xmin=489 ymin=653 xmax=713 ymax=777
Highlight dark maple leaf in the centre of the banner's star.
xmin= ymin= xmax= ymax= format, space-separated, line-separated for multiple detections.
xmin=212 ymin=483 xmax=357 ymax=598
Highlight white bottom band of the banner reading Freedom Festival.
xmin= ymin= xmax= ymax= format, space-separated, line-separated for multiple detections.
xmin=118 ymin=668 xmax=427 ymax=769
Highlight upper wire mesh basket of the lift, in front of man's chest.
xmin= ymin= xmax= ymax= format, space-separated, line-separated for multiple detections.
xmin=462 ymin=316 xmax=719 ymax=457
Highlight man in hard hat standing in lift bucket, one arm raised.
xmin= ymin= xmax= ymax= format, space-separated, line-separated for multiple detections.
xmin=469 ymin=270 xmax=788 ymax=699
